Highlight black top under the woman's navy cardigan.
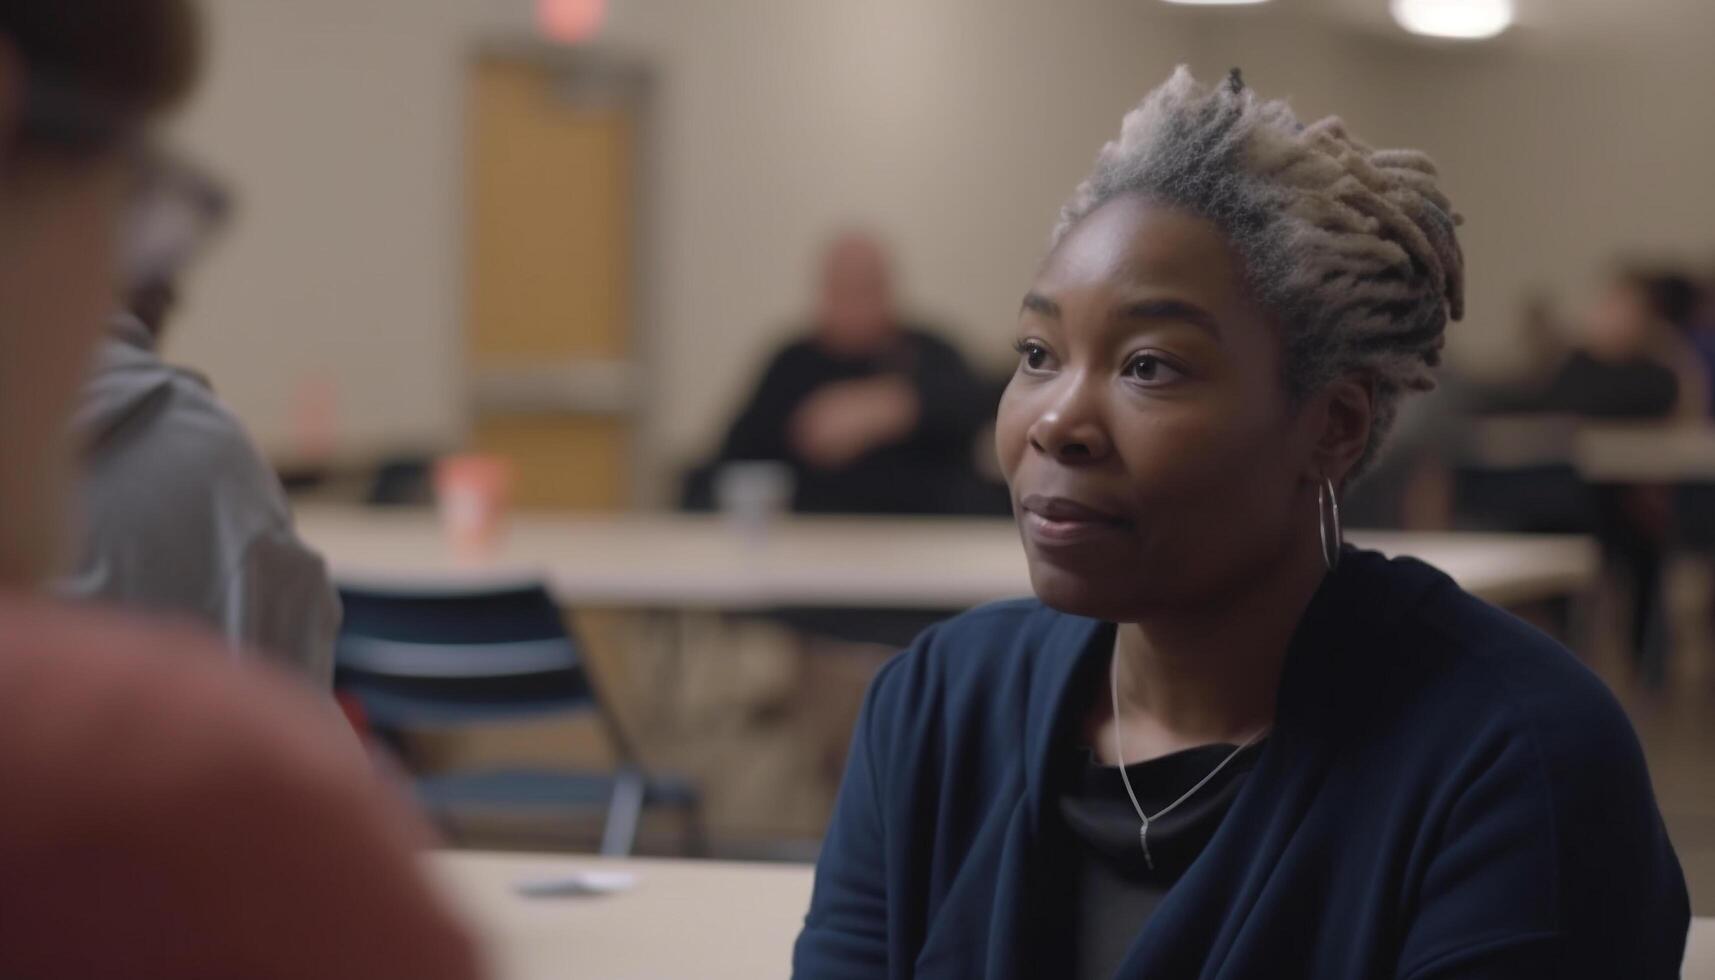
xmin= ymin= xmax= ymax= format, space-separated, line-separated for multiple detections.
xmin=1048 ymin=743 xmax=1262 ymax=980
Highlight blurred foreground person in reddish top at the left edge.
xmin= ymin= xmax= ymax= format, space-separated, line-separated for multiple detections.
xmin=0 ymin=0 xmax=477 ymax=980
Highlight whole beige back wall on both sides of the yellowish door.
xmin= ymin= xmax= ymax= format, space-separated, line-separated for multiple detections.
xmin=175 ymin=0 xmax=1715 ymax=473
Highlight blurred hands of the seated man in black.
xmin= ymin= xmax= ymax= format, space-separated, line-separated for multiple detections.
xmin=791 ymin=376 xmax=921 ymax=470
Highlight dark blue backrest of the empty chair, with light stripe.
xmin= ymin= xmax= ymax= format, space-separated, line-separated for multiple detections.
xmin=334 ymin=585 xmax=600 ymax=728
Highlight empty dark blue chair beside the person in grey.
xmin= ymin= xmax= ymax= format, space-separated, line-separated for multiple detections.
xmin=334 ymin=584 xmax=701 ymax=855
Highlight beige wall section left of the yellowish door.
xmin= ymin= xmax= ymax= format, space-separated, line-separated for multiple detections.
xmin=172 ymin=0 xmax=483 ymax=459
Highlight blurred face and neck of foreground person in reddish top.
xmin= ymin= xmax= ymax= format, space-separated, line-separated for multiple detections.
xmin=0 ymin=160 xmax=127 ymax=587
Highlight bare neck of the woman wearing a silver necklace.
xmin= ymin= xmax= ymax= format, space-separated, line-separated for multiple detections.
xmin=1089 ymin=554 xmax=1322 ymax=764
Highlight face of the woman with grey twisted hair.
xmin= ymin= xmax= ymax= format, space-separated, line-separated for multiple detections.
xmin=996 ymin=197 xmax=1319 ymax=621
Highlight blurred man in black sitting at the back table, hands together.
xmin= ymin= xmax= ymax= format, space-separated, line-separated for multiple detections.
xmin=689 ymin=232 xmax=1005 ymax=513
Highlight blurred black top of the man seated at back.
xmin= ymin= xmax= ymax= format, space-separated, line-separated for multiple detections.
xmin=719 ymin=328 xmax=996 ymax=513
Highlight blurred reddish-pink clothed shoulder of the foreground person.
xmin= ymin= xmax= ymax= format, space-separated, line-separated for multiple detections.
xmin=0 ymin=597 xmax=475 ymax=977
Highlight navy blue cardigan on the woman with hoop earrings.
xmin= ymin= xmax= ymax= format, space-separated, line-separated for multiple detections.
xmin=794 ymin=551 xmax=1689 ymax=980
